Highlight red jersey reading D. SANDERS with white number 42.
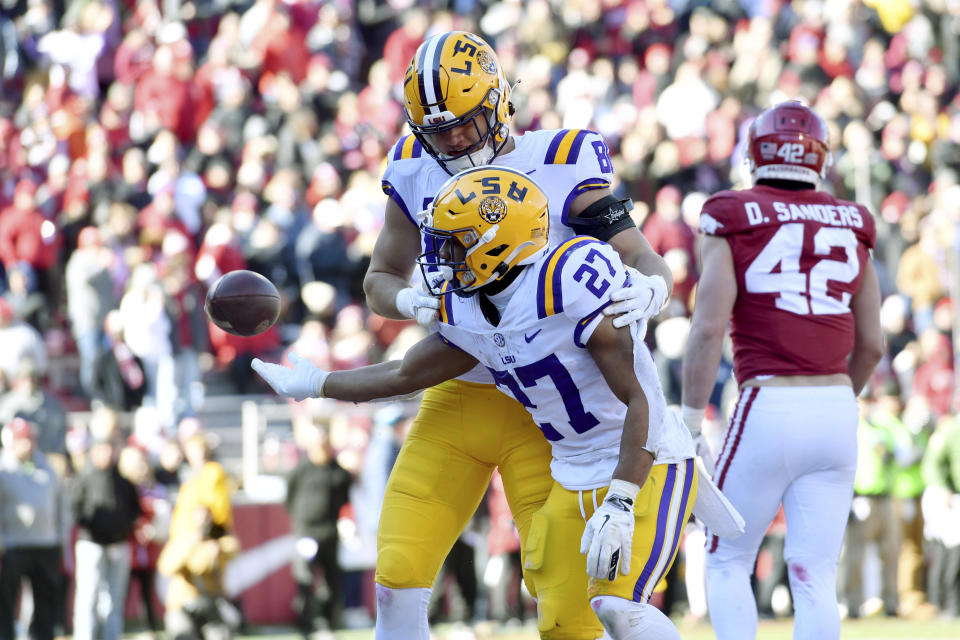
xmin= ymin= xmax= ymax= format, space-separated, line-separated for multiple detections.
xmin=700 ymin=185 xmax=877 ymax=382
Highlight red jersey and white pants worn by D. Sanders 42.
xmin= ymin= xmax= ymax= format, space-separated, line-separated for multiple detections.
xmin=700 ymin=185 xmax=876 ymax=640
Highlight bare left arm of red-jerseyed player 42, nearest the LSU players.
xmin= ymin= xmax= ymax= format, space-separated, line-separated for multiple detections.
xmin=682 ymin=235 xmax=737 ymax=412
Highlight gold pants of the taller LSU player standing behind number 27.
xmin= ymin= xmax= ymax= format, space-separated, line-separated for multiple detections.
xmin=376 ymin=380 xmax=553 ymax=593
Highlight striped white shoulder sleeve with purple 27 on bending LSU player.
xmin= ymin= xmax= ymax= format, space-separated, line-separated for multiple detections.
xmin=537 ymin=236 xmax=628 ymax=347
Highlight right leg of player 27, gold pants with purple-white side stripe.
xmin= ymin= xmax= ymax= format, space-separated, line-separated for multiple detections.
xmin=585 ymin=459 xmax=697 ymax=640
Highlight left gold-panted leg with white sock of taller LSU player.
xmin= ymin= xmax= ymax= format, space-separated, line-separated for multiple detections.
xmin=376 ymin=381 xmax=496 ymax=640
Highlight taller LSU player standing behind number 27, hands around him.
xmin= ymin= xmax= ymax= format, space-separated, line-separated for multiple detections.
xmin=364 ymin=31 xmax=672 ymax=640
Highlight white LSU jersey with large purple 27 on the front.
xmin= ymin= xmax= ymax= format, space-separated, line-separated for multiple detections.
xmin=440 ymin=236 xmax=693 ymax=491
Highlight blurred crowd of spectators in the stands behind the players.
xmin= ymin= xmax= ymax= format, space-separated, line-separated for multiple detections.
xmin=0 ymin=0 xmax=960 ymax=632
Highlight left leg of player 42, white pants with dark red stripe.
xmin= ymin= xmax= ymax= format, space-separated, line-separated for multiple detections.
xmin=706 ymin=388 xmax=789 ymax=640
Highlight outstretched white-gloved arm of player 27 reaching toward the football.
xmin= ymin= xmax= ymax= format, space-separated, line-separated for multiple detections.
xmin=251 ymin=333 xmax=477 ymax=402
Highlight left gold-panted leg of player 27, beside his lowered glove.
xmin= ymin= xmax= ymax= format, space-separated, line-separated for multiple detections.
xmin=524 ymin=483 xmax=603 ymax=640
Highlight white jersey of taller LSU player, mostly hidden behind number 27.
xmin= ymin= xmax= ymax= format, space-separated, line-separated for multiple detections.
xmin=381 ymin=129 xmax=613 ymax=384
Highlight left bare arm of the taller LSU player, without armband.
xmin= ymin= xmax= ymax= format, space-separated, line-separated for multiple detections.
xmin=363 ymin=199 xmax=434 ymax=320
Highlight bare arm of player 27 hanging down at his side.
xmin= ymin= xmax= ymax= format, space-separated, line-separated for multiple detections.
xmin=587 ymin=318 xmax=653 ymax=487
